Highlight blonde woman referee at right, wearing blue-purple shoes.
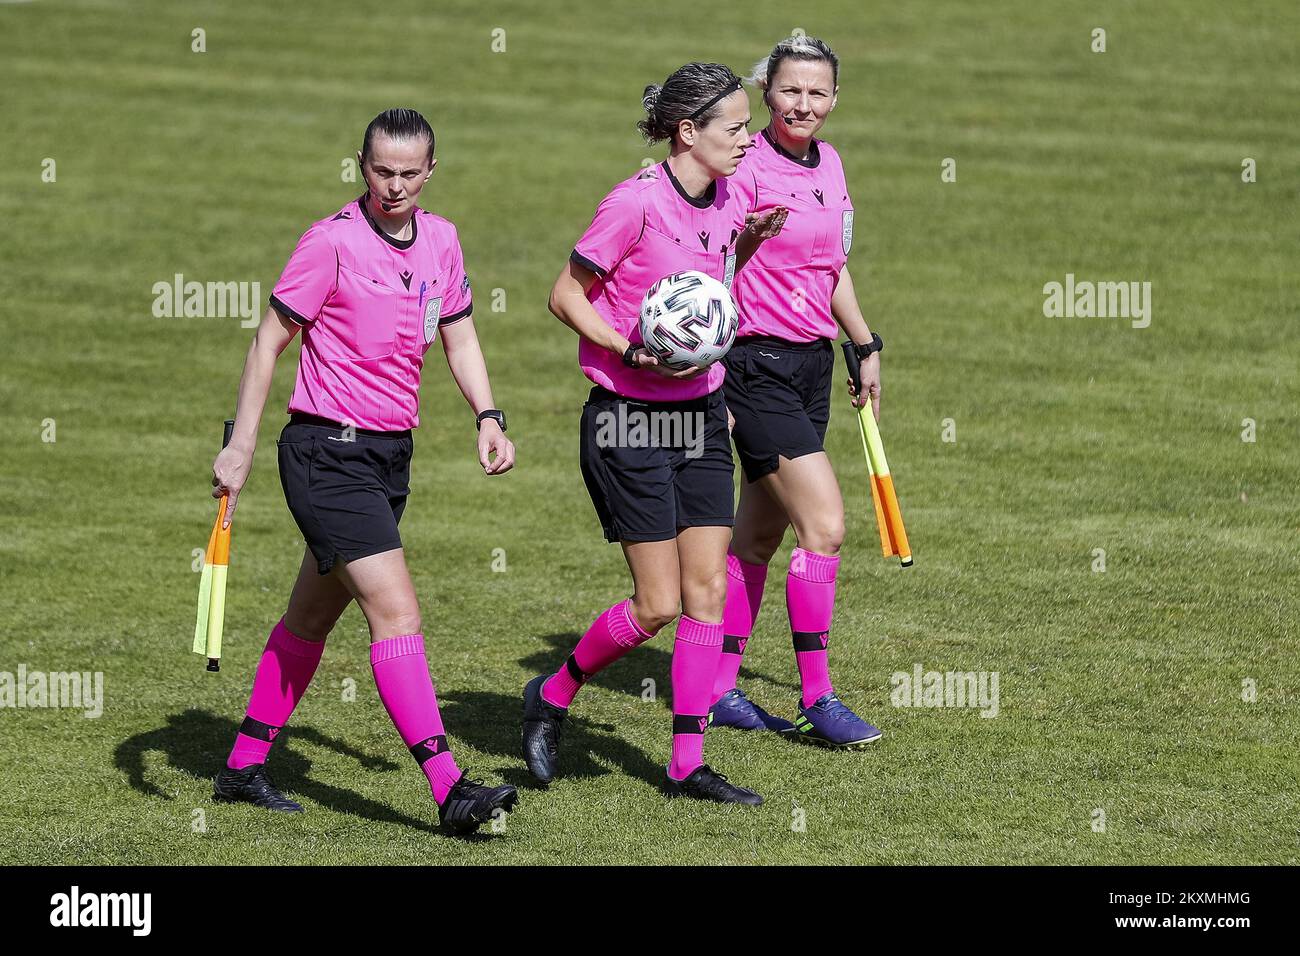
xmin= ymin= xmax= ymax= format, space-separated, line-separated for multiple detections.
xmin=711 ymin=36 xmax=881 ymax=748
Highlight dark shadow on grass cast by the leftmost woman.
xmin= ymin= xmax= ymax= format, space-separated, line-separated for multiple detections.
xmin=113 ymin=710 xmax=438 ymax=832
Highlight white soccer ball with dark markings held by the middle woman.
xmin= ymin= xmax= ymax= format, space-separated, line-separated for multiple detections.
xmin=641 ymin=272 xmax=738 ymax=369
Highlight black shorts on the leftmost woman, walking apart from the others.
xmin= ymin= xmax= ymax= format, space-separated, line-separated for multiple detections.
xmin=276 ymin=412 xmax=412 ymax=575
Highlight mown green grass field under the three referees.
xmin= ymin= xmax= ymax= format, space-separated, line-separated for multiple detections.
xmin=0 ymin=0 xmax=1300 ymax=864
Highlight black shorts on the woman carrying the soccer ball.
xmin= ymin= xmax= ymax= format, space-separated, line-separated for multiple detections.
xmin=581 ymin=386 xmax=736 ymax=541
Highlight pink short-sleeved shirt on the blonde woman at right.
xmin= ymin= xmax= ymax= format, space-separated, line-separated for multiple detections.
xmin=732 ymin=129 xmax=853 ymax=342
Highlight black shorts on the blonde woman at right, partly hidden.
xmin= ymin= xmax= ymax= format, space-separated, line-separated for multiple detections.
xmin=723 ymin=336 xmax=835 ymax=481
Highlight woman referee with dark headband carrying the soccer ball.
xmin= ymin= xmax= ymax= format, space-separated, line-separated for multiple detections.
xmin=523 ymin=62 xmax=780 ymax=805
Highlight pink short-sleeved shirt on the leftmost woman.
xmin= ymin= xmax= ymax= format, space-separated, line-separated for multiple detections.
xmin=270 ymin=196 xmax=473 ymax=432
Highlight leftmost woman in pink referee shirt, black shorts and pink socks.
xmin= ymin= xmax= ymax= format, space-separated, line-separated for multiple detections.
xmin=212 ymin=109 xmax=517 ymax=832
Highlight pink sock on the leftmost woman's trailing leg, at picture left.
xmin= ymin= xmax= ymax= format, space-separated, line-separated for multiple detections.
xmin=226 ymin=618 xmax=325 ymax=770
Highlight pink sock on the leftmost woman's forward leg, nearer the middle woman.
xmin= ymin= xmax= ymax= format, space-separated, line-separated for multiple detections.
xmin=371 ymin=633 xmax=460 ymax=804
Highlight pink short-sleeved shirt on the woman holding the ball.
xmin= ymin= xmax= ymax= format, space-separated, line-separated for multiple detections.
xmin=572 ymin=163 xmax=746 ymax=402
